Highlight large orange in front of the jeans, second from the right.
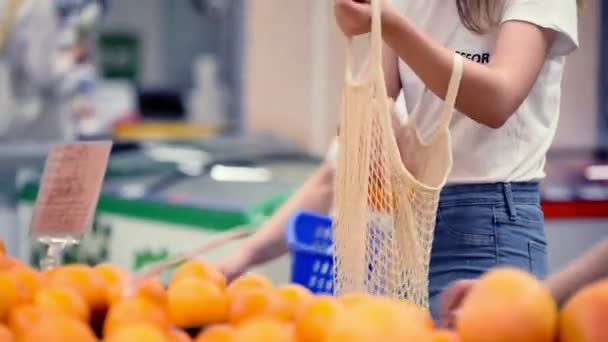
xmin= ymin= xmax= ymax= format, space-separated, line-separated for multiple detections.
xmin=456 ymin=268 xmax=557 ymax=342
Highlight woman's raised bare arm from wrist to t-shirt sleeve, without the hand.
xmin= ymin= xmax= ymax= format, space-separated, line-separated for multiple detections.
xmin=383 ymin=11 xmax=551 ymax=128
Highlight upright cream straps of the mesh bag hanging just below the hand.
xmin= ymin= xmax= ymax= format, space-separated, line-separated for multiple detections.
xmin=346 ymin=0 xmax=384 ymax=87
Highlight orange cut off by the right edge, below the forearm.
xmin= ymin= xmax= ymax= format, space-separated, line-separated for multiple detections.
xmin=559 ymin=280 xmax=608 ymax=342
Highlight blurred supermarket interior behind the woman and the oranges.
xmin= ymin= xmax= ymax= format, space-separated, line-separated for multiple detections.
xmin=0 ymin=0 xmax=608 ymax=281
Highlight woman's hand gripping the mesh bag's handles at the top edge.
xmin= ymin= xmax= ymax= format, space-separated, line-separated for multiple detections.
xmin=334 ymin=0 xmax=394 ymax=37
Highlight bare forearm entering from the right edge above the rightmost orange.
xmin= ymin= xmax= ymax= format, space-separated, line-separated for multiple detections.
xmin=546 ymin=240 xmax=608 ymax=306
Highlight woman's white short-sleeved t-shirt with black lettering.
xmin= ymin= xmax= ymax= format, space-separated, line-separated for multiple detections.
xmin=393 ymin=0 xmax=578 ymax=184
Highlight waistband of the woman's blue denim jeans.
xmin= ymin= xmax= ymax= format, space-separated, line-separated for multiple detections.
xmin=439 ymin=182 xmax=540 ymax=207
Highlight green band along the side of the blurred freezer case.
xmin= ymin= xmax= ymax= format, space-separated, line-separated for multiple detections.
xmin=19 ymin=184 xmax=290 ymax=231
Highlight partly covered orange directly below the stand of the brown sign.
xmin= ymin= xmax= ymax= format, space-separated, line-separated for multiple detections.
xmin=46 ymin=265 xmax=107 ymax=311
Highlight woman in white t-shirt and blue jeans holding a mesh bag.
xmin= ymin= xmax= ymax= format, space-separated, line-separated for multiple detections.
xmin=225 ymin=0 xmax=580 ymax=317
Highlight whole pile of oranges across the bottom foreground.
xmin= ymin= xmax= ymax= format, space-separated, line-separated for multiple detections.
xmin=0 ymin=238 xmax=608 ymax=342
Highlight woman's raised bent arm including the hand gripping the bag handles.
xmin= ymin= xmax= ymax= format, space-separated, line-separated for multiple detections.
xmin=334 ymin=0 xmax=555 ymax=128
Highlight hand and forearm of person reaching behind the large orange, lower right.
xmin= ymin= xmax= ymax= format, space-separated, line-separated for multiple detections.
xmin=440 ymin=239 xmax=608 ymax=328
